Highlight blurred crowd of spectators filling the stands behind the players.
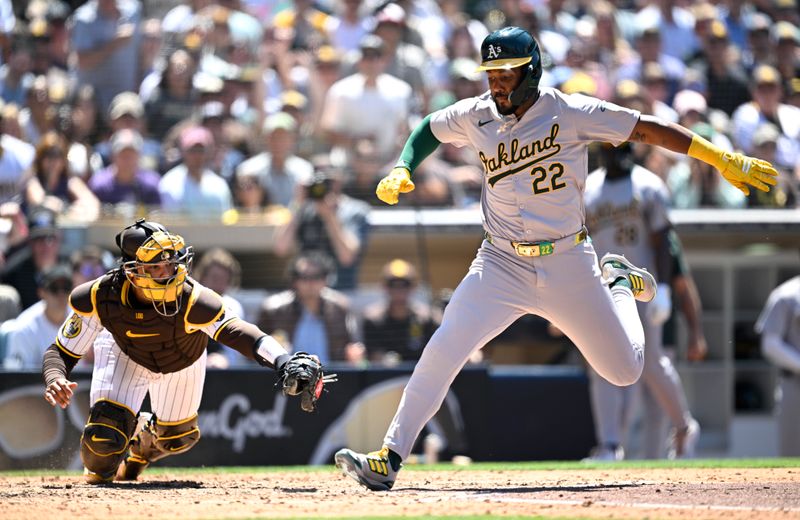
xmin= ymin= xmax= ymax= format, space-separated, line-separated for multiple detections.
xmin=0 ymin=0 xmax=800 ymax=374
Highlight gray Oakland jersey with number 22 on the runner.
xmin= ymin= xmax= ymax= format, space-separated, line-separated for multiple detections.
xmin=431 ymin=87 xmax=639 ymax=242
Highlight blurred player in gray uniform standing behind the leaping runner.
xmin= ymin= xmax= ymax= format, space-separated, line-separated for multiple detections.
xmin=584 ymin=143 xmax=700 ymax=460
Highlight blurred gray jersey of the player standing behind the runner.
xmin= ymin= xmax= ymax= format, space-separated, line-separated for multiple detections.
xmin=584 ymin=166 xmax=669 ymax=273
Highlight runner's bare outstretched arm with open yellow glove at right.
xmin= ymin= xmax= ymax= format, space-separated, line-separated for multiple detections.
xmin=629 ymin=115 xmax=778 ymax=195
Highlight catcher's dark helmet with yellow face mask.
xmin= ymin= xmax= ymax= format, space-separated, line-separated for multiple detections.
xmin=116 ymin=219 xmax=194 ymax=316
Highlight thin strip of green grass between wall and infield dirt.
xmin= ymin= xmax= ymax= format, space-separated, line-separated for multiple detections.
xmin=0 ymin=458 xmax=800 ymax=480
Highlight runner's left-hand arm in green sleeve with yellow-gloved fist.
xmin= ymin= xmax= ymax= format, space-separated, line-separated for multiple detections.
xmin=375 ymin=114 xmax=441 ymax=204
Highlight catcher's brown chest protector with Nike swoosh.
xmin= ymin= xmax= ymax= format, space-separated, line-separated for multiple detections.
xmin=81 ymin=273 xmax=222 ymax=374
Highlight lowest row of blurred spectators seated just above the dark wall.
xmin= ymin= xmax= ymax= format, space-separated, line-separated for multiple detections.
xmin=0 ymin=213 xmax=450 ymax=371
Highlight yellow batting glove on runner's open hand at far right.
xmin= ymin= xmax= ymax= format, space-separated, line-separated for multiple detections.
xmin=688 ymin=135 xmax=778 ymax=195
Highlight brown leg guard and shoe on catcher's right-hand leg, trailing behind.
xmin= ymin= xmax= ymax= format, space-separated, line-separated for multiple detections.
xmin=117 ymin=414 xmax=200 ymax=480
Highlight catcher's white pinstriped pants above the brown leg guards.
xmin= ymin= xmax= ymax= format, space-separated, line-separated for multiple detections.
xmin=90 ymin=330 xmax=206 ymax=422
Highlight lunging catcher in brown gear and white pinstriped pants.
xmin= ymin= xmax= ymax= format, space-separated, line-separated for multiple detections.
xmin=42 ymin=219 xmax=323 ymax=484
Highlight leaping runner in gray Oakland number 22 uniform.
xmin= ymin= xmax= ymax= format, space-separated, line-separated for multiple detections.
xmin=335 ymin=27 xmax=777 ymax=490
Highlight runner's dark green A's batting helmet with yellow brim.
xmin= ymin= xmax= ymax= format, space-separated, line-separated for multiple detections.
xmin=477 ymin=27 xmax=542 ymax=110
